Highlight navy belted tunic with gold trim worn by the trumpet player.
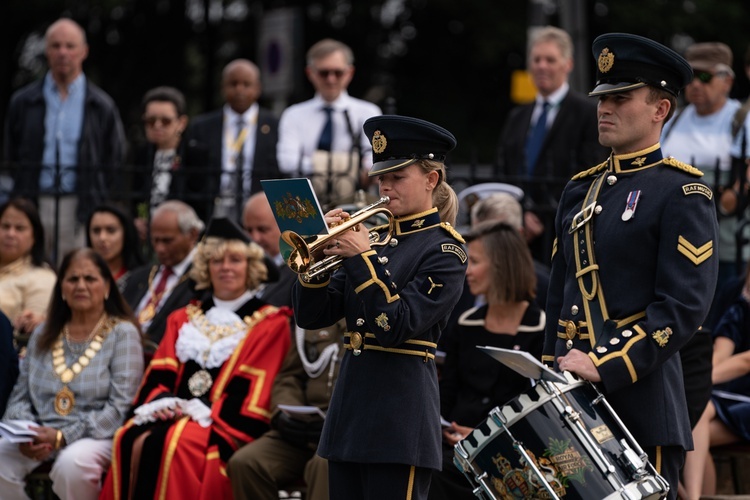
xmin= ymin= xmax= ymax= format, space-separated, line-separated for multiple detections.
xmin=293 ymin=209 xmax=467 ymax=469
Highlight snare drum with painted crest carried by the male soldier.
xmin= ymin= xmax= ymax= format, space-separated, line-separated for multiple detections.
xmin=454 ymin=373 xmax=669 ymax=500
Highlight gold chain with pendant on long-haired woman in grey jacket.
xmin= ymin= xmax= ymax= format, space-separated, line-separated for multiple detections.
xmin=52 ymin=312 xmax=117 ymax=416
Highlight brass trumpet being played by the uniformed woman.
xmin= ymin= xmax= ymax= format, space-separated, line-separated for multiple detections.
xmin=281 ymin=196 xmax=396 ymax=281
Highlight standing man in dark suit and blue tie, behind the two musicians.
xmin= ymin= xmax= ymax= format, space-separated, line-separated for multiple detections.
xmin=497 ymin=26 xmax=608 ymax=262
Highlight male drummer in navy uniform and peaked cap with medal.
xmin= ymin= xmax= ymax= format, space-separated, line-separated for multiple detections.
xmin=543 ymin=33 xmax=718 ymax=498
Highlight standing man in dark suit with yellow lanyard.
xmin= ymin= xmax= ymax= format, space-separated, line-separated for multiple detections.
xmin=185 ymin=59 xmax=280 ymax=221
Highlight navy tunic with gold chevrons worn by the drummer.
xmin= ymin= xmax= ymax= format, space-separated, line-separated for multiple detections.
xmin=543 ymin=144 xmax=718 ymax=449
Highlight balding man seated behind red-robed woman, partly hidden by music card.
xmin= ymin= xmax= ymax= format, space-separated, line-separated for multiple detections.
xmin=242 ymin=192 xmax=297 ymax=307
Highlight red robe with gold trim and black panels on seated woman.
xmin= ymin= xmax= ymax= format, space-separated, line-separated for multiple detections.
xmin=99 ymin=299 xmax=291 ymax=500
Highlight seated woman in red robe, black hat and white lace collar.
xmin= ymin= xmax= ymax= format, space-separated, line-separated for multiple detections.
xmin=100 ymin=218 xmax=291 ymax=500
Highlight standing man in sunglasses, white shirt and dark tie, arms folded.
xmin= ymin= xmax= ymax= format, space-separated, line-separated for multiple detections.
xmin=277 ymin=39 xmax=382 ymax=205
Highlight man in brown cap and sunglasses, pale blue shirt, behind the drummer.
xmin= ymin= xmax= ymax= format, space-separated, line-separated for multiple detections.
xmin=661 ymin=42 xmax=748 ymax=328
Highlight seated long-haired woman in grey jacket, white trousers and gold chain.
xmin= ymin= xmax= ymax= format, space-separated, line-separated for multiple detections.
xmin=0 ymin=248 xmax=143 ymax=500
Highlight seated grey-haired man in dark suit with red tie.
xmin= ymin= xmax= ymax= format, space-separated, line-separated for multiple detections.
xmin=122 ymin=200 xmax=204 ymax=344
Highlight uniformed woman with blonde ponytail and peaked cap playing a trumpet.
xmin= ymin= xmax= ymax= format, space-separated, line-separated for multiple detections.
xmin=292 ymin=115 xmax=466 ymax=500
